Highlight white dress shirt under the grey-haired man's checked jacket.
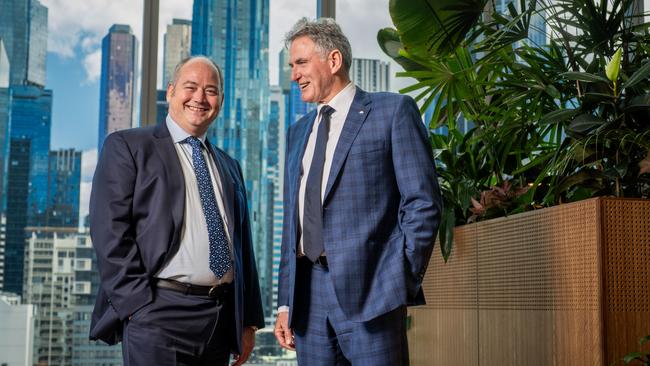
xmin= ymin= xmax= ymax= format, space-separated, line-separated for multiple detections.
xmin=298 ymin=82 xmax=357 ymax=255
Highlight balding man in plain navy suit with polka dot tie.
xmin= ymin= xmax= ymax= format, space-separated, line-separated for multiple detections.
xmin=90 ymin=56 xmax=264 ymax=366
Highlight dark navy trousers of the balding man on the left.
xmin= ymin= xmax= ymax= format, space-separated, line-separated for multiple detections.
xmin=122 ymin=288 xmax=235 ymax=366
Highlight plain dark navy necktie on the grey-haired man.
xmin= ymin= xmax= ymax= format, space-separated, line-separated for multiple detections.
xmin=302 ymin=105 xmax=334 ymax=262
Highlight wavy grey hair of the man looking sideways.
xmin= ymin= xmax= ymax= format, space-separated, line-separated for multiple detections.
xmin=284 ymin=18 xmax=352 ymax=73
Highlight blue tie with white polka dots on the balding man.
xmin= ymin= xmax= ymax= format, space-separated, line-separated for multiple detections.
xmin=185 ymin=136 xmax=230 ymax=278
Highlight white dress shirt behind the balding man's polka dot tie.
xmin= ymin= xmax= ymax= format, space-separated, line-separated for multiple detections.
xmin=156 ymin=115 xmax=233 ymax=286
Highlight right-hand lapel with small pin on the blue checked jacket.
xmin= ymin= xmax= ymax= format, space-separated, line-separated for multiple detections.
xmin=323 ymin=88 xmax=372 ymax=202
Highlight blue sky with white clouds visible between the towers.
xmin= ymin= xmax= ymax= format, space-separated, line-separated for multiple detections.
xmin=41 ymin=0 xmax=397 ymax=150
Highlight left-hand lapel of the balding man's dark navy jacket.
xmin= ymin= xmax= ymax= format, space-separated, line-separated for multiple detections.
xmin=154 ymin=123 xmax=185 ymax=246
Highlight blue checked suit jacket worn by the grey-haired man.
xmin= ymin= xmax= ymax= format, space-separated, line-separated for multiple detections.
xmin=278 ymin=88 xmax=442 ymax=322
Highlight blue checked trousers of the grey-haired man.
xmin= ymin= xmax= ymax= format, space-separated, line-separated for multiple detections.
xmin=293 ymin=258 xmax=409 ymax=366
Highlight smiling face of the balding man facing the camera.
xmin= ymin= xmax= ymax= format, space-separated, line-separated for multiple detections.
xmin=167 ymin=59 xmax=223 ymax=136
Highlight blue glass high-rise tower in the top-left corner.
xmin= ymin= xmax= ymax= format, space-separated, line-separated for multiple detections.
xmin=0 ymin=0 xmax=47 ymax=86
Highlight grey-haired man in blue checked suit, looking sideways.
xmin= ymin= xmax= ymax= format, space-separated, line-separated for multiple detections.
xmin=275 ymin=19 xmax=441 ymax=366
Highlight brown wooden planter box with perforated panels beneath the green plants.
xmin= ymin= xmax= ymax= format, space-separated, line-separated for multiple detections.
xmin=408 ymin=198 xmax=650 ymax=366
